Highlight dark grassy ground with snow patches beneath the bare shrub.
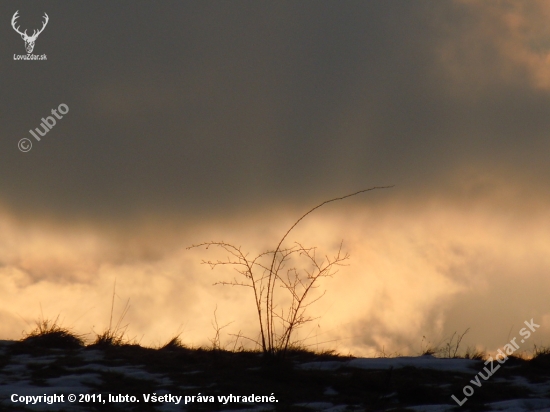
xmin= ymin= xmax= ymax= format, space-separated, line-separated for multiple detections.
xmin=0 ymin=337 xmax=550 ymax=412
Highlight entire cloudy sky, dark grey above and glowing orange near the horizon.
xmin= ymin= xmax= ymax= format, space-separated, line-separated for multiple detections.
xmin=0 ymin=0 xmax=550 ymax=356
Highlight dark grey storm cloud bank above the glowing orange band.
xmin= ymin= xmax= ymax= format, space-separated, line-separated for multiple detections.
xmin=0 ymin=1 xmax=524 ymax=224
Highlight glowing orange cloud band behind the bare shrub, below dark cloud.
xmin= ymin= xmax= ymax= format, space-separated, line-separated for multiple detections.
xmin=0 ymin=178 xmax=550 ymax=355
